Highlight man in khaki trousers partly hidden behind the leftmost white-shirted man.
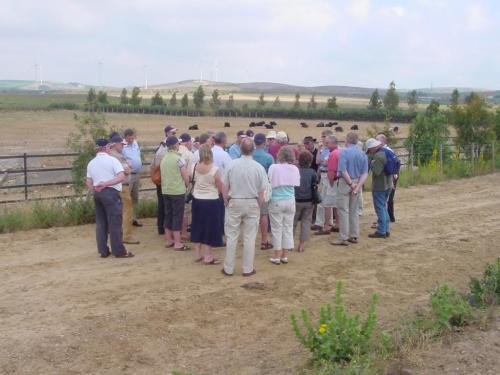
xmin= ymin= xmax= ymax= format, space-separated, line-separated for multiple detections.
xmin=110 ymin=134 xmax=139 ymax=244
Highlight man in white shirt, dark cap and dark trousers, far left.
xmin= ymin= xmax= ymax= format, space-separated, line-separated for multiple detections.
xmin=86 ymin=139 xmax=134 ymax=258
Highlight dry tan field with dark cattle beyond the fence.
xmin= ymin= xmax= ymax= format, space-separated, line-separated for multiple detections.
xmin=0 ymin=111 xmax=408 ymax=155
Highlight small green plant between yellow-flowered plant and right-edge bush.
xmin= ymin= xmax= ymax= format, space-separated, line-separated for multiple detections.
xmin=431 ymin=284 xmax=472 ymax=330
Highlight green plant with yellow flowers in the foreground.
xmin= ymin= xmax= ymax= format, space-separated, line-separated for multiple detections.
xmin=290 ymin=281 xmax=378 ymax=364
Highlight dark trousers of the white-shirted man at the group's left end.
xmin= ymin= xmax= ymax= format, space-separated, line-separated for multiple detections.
xmin=94 ymin=188 xmax=127 ymax=256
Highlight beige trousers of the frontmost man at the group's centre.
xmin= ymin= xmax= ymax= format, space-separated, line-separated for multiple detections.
xmin=224 ymin=199 xmax=260 ymax=274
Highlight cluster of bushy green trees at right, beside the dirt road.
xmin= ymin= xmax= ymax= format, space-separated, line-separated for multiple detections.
xmin=405 ymin=89 xmax=500 ymax=163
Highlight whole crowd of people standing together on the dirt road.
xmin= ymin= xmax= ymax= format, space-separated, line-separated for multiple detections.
xmin=87 ymin=125 xmax=397 ymax=276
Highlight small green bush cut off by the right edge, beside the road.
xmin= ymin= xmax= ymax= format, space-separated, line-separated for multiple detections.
xmin=469 ymin=258 xmax=500 ymax=307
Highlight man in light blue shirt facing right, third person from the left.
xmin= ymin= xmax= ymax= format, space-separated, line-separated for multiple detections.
xmin=122 ymin=129 xmax=142 ymax=227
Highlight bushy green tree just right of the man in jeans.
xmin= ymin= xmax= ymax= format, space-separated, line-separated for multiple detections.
xmin=405 ymin=102 xmax=450 ymax=164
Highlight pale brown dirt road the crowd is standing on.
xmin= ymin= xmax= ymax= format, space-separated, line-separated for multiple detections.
xmin=0 ymin=174 xmax=500 ymax=375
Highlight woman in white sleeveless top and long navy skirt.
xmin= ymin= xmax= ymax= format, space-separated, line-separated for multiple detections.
xmin=191 ymin=144 xmax=224 ymax=264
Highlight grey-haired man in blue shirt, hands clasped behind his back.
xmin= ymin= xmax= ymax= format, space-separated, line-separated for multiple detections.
xmin=331 ymin=132 xmax=368 ymax=246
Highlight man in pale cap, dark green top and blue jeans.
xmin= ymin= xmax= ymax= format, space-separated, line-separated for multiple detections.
xmin=366 ymin=138 xmax=393 ymax=238
